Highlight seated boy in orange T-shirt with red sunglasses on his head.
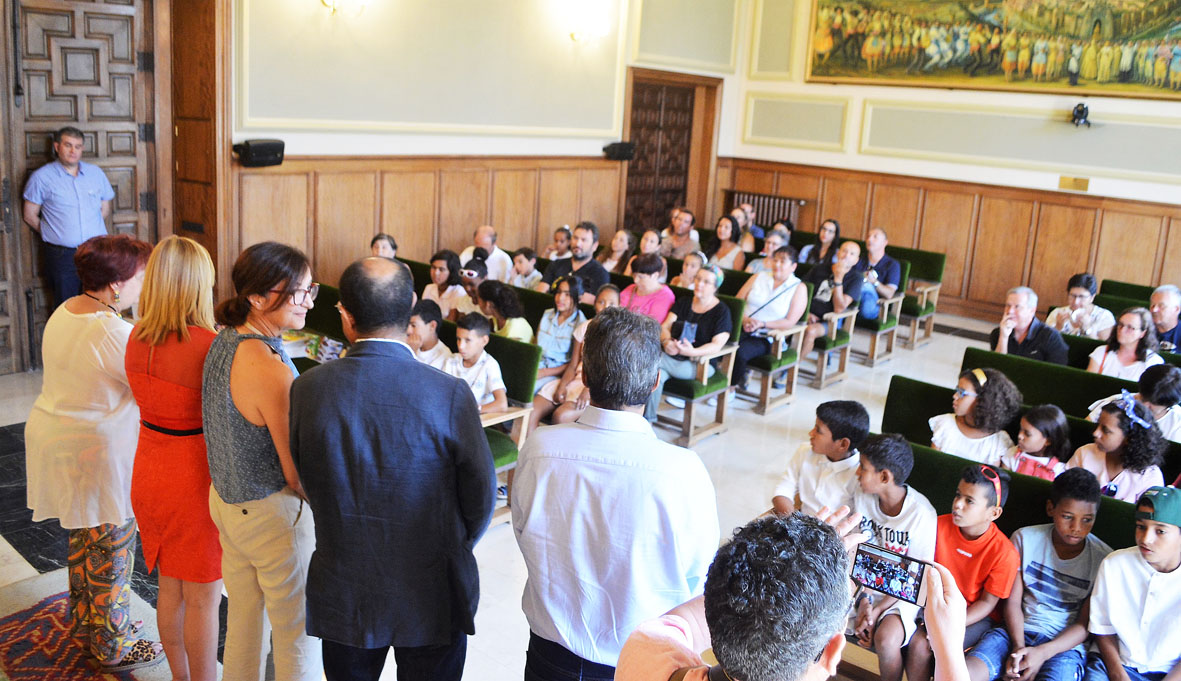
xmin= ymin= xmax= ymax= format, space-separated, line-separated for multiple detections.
xmin=906 ymin=464 xmax=1022 ymax=681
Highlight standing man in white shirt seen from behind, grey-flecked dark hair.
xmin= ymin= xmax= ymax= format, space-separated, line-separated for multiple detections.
xmin=513 ymin=308 xmax=718 ymax=681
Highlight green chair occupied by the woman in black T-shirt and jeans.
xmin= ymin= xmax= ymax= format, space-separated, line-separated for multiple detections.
xmin=657 ymin=295 xmax=745 ymax=447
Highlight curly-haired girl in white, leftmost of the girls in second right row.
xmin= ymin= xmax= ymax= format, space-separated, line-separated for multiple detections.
xmin=927 ymin=369 xmax=1022 ymax=466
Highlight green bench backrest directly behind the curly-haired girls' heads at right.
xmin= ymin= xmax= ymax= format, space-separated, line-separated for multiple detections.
xmin=960 ymin=348 xmax=1138 ymax=417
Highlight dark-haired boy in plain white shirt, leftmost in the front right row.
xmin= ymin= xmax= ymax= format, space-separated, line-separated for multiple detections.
xmin=771 ymin=400 xmax=869 ymax=516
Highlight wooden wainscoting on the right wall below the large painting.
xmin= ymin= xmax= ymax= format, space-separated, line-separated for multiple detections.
xmin=715 ymin=158 xmax=1181 ymax=319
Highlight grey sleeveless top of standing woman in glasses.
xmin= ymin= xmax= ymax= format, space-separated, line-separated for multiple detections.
xmin=201 ymin=327 xmax=299 ymax=504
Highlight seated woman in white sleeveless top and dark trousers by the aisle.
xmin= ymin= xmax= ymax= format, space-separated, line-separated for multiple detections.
xmin=730 ymin=246 xmax=808 ymax=387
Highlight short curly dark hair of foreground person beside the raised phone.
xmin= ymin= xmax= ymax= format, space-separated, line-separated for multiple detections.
xmin=705 ymin=513 xmax=849 ymax=681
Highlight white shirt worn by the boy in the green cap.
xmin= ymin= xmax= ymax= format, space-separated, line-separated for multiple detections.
xmin=1088 ymin=546 xmax=1181 ymax=674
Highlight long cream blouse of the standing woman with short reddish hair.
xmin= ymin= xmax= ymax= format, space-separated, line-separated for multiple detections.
xmin=25 ymin=305 xmax=139 ymax=530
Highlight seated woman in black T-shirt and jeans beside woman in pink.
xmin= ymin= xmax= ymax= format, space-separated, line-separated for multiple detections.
xmin=644 ymin=264 xmax=733 ymax=421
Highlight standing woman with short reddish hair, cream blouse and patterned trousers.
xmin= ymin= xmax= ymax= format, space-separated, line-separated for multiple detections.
xmin=25 ymin=234 xmax=164 ymax=673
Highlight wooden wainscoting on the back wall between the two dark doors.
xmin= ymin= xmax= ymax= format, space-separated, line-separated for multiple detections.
xmin=222 ymin=157 xmax=622 ymax=293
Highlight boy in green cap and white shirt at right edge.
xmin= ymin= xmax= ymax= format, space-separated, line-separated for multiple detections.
xmin=1083 ymin=487 xmax=1181 ymax=681
